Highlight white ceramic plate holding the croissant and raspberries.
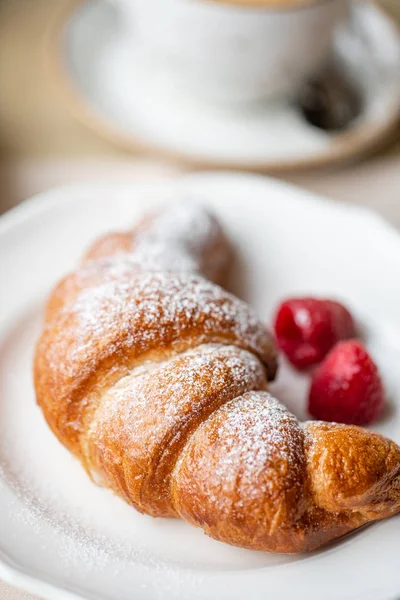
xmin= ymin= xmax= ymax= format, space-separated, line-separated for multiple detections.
xmin=0 ymin=174 xmax=400 ymax=600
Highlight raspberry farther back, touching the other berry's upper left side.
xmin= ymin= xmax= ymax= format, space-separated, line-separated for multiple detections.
xmin=275 ymin=298 xmax=356 ymax=370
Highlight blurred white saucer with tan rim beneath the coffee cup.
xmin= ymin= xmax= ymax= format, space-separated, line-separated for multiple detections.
xmin=47 ymin=0 xmax=400 ymax=170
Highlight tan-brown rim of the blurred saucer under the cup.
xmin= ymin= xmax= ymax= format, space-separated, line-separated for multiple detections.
xmin=41 ymin=0 xmax=400 ymax=175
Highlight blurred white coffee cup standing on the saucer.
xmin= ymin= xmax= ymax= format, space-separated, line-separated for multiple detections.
xmin=114 ymin=0 xmax=348 ymax=104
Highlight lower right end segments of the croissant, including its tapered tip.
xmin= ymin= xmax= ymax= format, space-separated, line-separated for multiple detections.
xmin=172 ymin=392 xmax=400 ymax=553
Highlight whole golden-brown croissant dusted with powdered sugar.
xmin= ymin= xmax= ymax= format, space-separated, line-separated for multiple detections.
xmin=34 ymin=203 xmax=400 ymax=553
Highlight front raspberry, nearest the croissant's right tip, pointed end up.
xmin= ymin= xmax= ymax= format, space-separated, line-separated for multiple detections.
xmin=308 ymin=340 xmax=383 ymax=425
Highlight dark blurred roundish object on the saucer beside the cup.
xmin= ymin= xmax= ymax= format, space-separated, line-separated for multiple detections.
xmin=298 ymin=63 xmax=363 ymax=131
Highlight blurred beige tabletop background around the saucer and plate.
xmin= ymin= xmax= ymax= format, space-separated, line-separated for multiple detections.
xmin=0 ymin=0 xmax=400 ymax=225
